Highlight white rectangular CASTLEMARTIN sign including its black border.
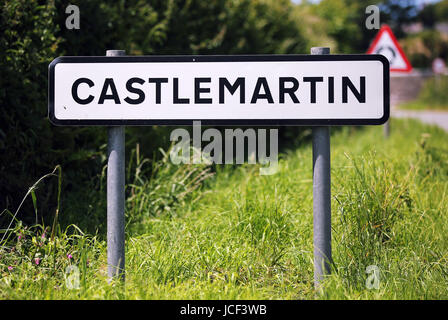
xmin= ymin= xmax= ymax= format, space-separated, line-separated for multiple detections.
xmin=49 ymin=55 xmax=389 ymax=125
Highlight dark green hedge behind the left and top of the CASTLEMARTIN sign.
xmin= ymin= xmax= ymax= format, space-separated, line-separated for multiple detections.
xmin=0 ymin=0 xmax=312 ymax=230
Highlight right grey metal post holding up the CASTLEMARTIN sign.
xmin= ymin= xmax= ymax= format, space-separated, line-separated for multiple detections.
xmin=311 ymin=47 xmax=331 ymax=287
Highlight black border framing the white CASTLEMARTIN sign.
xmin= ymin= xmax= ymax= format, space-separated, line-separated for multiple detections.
xmin=48 ymin=54 xmax=390 ymax=126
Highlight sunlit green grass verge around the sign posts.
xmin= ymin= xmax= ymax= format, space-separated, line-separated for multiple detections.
xmin=0 ymin=120 xmax=448 ymax=299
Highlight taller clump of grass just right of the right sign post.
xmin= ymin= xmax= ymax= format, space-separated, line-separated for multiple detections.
xmin=335 ymin=153 xmax=415 ymax=289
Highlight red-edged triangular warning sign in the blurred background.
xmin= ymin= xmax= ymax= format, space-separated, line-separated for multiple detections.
xmin=367 ymin=25 xmax=412 ymax=72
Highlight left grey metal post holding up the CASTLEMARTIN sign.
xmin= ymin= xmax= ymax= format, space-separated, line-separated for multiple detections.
xmin=106 ymin=50 xmax=126 ymax=280
